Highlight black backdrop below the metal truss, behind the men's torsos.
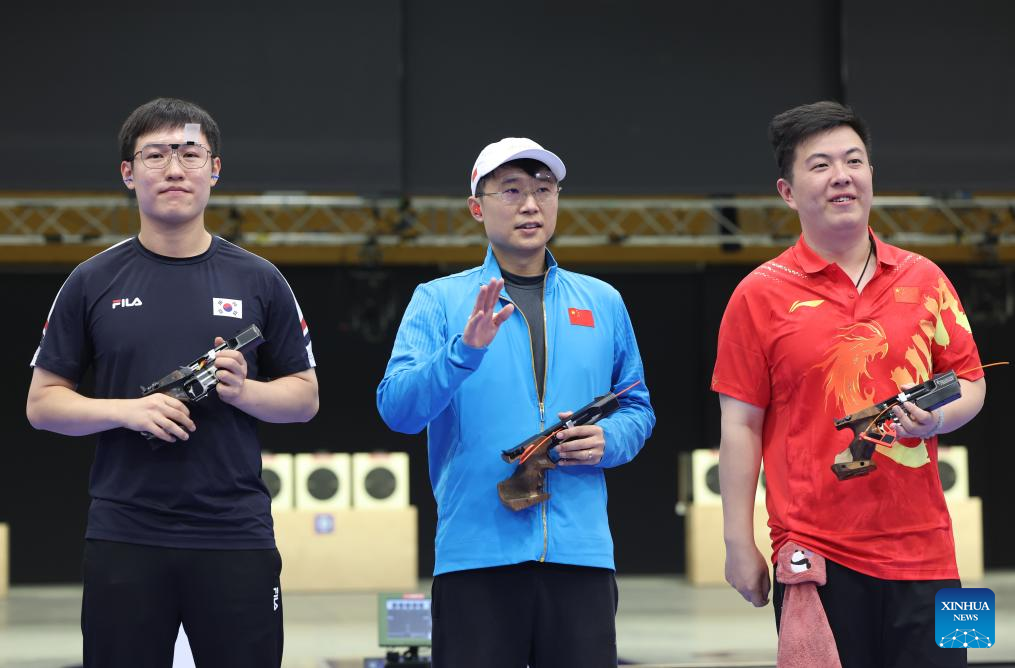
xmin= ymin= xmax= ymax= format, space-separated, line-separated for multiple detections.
xmin=0 ymin=259 xmax=1015 ymax=583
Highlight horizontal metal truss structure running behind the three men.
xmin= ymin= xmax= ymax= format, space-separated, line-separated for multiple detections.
xmin=0 ymin=195 xmax=1015 ymax=264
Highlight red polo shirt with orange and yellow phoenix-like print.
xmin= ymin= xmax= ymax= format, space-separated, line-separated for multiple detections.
xmin=712 ymin=232 xmax=984 ymax=580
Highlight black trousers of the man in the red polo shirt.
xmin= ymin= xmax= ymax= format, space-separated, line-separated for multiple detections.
xmin=772 ymin=559 xmax=966 ymax=668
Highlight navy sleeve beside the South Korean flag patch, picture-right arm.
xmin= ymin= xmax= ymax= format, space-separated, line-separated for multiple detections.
xmin=257 ymin=266 xmax=317 ymax=378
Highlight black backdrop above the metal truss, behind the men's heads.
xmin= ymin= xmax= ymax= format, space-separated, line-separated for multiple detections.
xmin=0 ymin=0 xmax=1015 ymax=195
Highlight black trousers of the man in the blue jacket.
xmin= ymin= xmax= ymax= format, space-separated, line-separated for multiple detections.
xmin=430 ymin=561 xmax=617 ymax=668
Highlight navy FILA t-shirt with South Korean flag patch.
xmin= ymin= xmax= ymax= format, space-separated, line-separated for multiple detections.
xmin=31 ymin=237 xmax=315 ymax=549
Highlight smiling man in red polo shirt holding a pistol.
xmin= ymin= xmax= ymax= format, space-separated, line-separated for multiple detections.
xmin=712 ymin=102 xmax=986 ymax=668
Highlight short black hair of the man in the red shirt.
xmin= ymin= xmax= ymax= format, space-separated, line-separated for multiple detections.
xmin=768 ymin=101 xmax=871 ymax=181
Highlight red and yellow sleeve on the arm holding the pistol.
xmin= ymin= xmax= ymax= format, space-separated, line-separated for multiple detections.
xmin=924 ymin=269 xmax=984 ymax=381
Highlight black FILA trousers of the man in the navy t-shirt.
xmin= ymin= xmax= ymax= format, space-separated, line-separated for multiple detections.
xmin=81 ymin=540 xmax=282 ymax=668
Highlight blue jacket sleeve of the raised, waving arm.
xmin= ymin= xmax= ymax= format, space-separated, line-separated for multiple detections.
xmin=377 ymin=284 xmax=486 ymax=433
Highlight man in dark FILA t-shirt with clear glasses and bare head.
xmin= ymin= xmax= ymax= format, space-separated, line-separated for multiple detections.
xmin=27 ymin=98 xmax=318 ymax=668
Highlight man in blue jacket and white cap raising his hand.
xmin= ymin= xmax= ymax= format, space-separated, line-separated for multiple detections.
xmin=378 ymin=137 xmax=656 ymax=668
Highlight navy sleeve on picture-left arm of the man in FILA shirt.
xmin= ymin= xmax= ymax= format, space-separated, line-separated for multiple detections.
xmin=31 ymin=268 xmax=92 ymax=385
